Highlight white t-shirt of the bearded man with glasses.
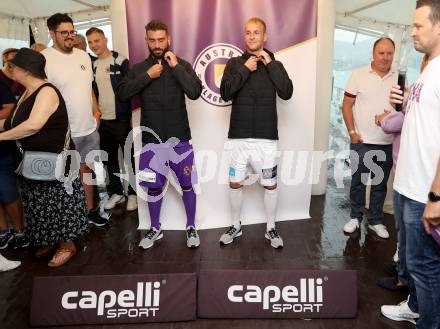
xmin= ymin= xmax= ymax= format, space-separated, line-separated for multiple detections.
xmin=41 ymin=47 xmax=96 ymax=137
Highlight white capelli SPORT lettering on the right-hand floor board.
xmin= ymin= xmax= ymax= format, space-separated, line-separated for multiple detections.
xmin=228 ymin=278 xmax=327 ymax=313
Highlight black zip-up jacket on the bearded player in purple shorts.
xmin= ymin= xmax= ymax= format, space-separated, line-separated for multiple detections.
xmin=117 ymin=55 xmax=202 ymax=144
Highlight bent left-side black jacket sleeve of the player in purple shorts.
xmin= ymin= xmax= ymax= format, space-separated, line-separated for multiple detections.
xmin=116 ymin=66 xmax=152 ymax=102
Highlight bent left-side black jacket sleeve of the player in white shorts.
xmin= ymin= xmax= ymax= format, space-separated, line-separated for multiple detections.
xmin=220 ymin=58 xmax=251 ymax=102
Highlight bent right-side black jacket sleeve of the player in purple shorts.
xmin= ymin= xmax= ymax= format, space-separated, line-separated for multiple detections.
xmin=171 ymin=60 xmax=202 ymax=100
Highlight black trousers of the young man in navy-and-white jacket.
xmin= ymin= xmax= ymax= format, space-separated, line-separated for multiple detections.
xmin=99 ymin=120 xmax=136 ymax=195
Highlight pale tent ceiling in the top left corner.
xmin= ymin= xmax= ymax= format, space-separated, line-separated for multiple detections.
xmin=0 ymin=0 xmax=110 ymax=18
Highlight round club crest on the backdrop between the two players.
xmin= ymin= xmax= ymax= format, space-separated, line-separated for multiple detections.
xmin=194 ymin=43 xmax=243 ymax=106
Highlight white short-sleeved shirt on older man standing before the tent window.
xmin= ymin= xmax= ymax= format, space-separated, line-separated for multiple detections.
xmin=345 ymin=64 xmax=398 ymax=145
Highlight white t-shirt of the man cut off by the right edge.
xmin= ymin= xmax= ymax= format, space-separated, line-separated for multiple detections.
xmin=394 ymin=56 xmax=440 ymax=203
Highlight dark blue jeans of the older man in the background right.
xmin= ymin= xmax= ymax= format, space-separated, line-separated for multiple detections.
xmin=350 ymin=143 xmax=393 ymax=225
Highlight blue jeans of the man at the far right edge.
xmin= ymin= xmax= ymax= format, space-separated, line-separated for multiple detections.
xmin=396 ymin=192 xmax=440 ymax=329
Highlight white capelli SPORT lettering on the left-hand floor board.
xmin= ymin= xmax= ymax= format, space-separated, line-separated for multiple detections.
xmin=61 ymin=281 xmax=162 ymax=319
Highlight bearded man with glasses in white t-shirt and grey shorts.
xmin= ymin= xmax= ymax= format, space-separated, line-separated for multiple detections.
xmin=41 ymin=13 xmax=107 ymax=226
